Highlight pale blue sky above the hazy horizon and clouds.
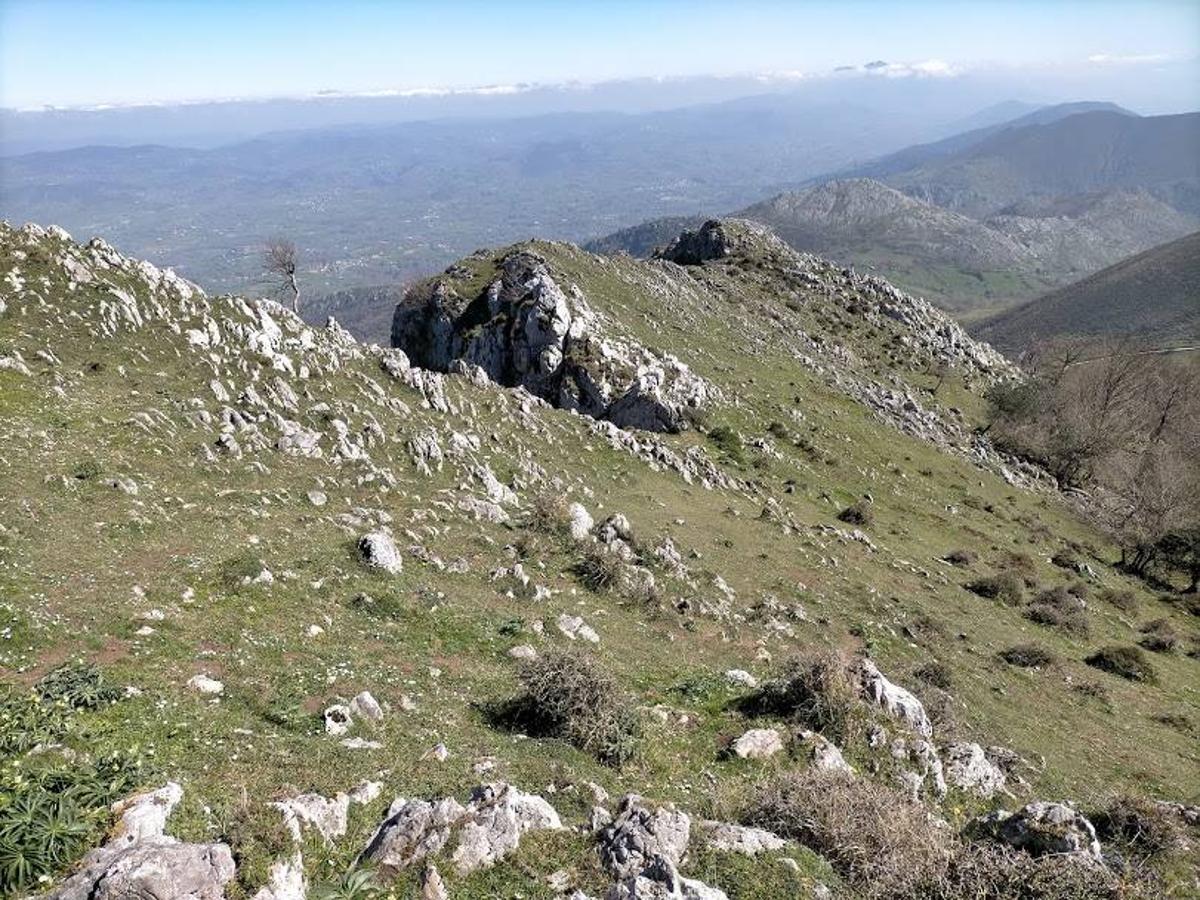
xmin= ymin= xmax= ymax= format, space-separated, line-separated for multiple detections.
xmin=0 ymin=0 xmax=1200 ymax=108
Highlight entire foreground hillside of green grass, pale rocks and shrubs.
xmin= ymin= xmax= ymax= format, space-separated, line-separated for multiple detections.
xmin=0 ymin=221 xmax=1200 ymax=900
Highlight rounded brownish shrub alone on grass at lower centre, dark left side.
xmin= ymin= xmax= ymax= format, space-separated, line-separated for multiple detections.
xmin=503 ymin=652 xmax=640 ymax=766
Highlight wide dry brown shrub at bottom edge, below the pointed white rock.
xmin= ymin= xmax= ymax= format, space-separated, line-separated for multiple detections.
xmin=745 ymin=769 xmax=954 ymax=899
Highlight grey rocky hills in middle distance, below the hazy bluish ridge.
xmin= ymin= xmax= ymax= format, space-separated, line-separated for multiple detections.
xmin=586 ymin=178 xmax=1200 ymax=320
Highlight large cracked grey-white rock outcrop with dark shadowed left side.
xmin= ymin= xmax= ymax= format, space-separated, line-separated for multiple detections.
xmin=391 ymin=251 xmax=713 ymax=432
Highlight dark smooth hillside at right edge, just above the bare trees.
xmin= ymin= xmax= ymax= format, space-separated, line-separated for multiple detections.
xmin=974 ymin=232 xmax=1200 ymax=354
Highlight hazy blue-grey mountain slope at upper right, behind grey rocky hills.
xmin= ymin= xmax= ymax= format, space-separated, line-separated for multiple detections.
xmin=886 ymin=112 xmax=1200 ymax=218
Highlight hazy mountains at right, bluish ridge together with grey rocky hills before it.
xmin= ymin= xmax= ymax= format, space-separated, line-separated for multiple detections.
xmin=588 ymin=103 xmax=1200 ymax=318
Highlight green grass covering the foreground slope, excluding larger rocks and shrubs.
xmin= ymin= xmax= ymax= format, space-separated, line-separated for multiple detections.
xmin=0 ymin=224 xmax=1200 ymax=898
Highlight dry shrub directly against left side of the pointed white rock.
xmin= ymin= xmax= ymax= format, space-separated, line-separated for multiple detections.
xmin=743 ymin=649 xmax=863 ymax=743
